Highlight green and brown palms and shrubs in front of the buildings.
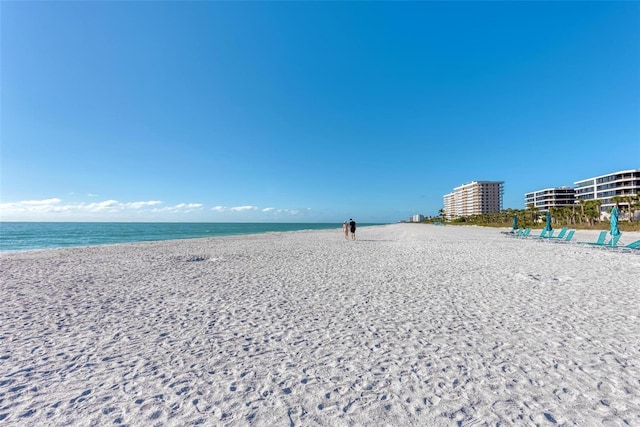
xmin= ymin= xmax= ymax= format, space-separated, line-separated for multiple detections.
xmin=424 ymin=195 xmax=640 ymax=231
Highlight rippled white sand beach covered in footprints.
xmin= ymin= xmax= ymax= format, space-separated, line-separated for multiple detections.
xmin=0 ymin=224 xmax=640 ymax=426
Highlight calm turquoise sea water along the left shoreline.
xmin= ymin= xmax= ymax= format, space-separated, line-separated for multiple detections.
xmin=0 ymin=222 xmax=382 ymax=252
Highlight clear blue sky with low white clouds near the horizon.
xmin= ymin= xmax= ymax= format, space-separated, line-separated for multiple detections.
xmin=0 ymin=1 xmax=640 ymax=222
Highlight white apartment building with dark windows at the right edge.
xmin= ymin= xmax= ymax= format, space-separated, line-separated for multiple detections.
xmin=574 ymin=169 xmax=640 ymax=217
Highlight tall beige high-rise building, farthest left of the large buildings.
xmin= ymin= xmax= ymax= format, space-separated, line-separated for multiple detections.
xmin=444 ymin=181 xmax=504 ymax=219
